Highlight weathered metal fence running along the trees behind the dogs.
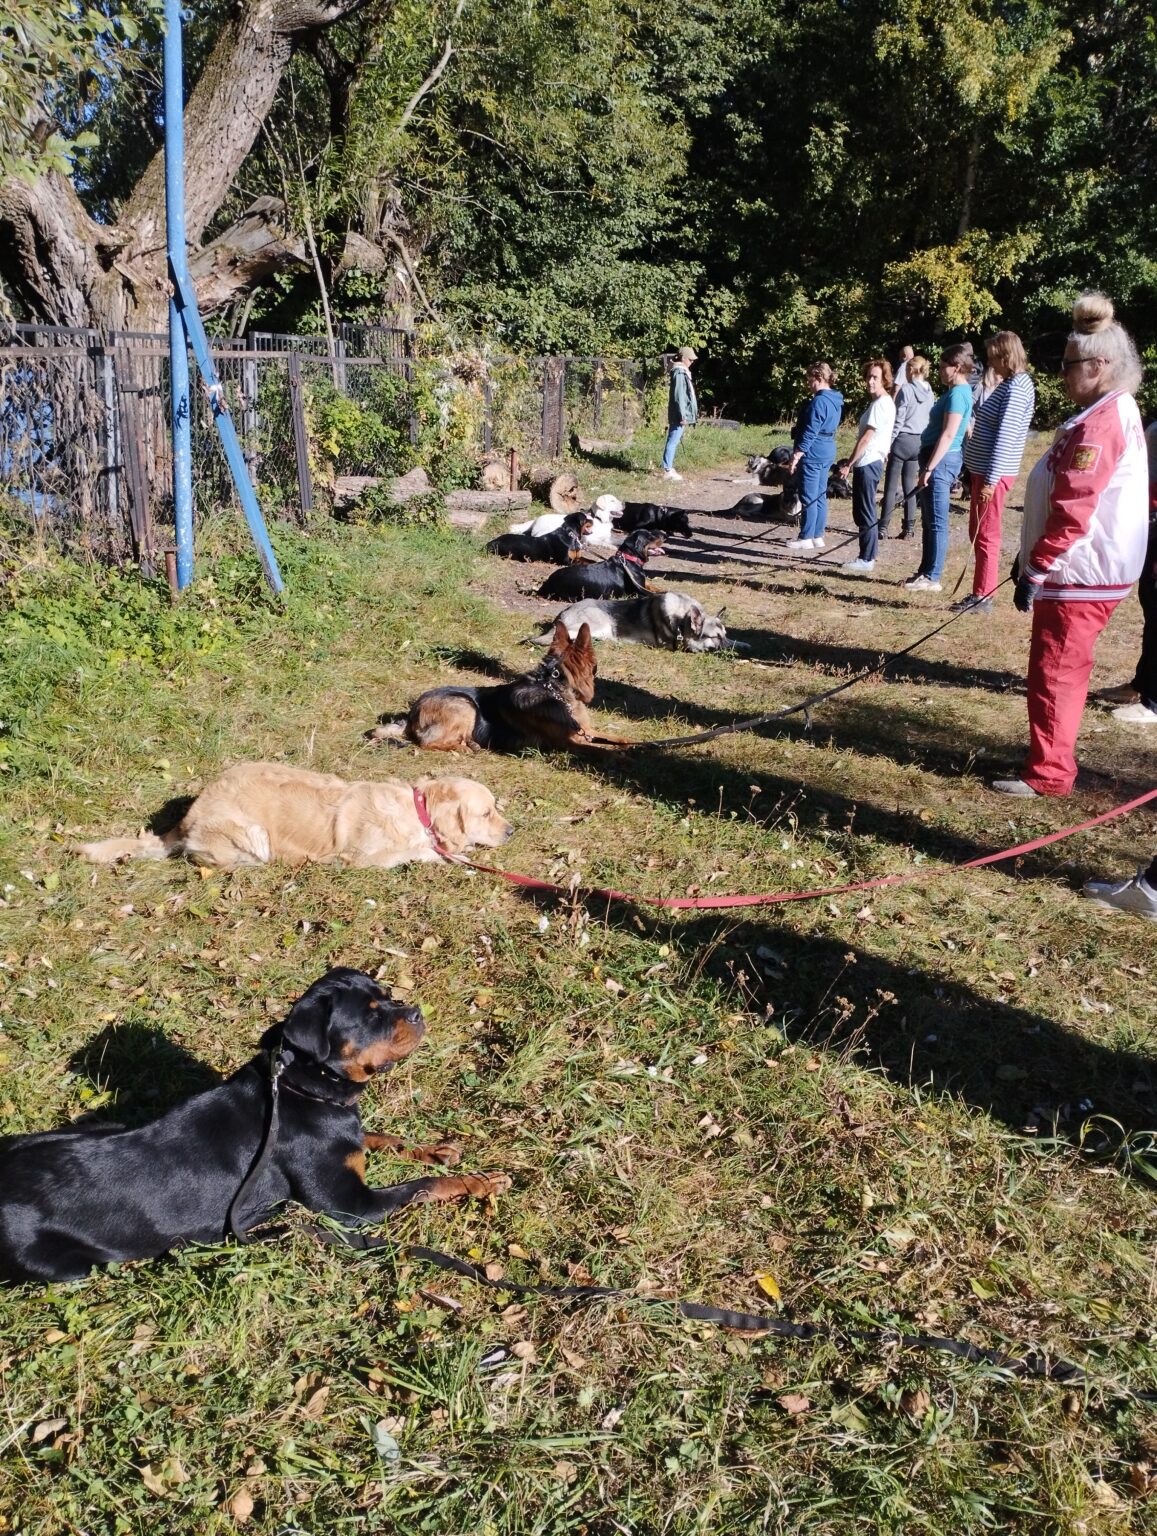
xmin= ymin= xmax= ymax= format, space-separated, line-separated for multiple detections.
xmin=0 ymin=324 xmax=667 ymax=571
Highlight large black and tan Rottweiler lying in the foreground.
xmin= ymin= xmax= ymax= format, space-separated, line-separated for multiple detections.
xmin=0 ymin=966 xmax=510 ymax=1281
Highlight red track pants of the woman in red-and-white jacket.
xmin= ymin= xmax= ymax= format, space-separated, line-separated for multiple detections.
xmin=1020 ymin=598 xmax=1120 ymax=794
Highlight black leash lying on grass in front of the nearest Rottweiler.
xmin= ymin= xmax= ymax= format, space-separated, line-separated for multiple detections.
xmin=306 ymin=1226 xmax=1157 ymax=1402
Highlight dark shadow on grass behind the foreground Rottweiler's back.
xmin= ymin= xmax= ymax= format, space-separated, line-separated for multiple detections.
xmin=69 ymin=1023 xmax=223 ymax=1132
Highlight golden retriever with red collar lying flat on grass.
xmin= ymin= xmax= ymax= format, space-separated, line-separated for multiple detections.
xmin=77 ymin=763 xmax=513 ymax=869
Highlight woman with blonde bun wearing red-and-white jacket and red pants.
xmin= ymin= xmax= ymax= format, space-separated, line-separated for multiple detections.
xmin=993 ymin=293 xmax=1149 ymax=796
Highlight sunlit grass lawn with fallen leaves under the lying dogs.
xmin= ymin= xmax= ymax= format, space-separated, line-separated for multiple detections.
xmin=0 ymin=429 xmax=1157 ymax=1536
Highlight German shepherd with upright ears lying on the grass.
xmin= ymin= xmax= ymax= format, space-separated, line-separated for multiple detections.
xmin=366 ymin=624 xmax=625 ymax=753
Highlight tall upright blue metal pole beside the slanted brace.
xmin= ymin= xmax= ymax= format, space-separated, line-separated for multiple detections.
xmin=164 ymin=0 xmax=194 ymax=590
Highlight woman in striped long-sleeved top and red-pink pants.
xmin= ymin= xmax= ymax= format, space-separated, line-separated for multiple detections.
xmin=953 ymin=330 xmax=1037 ymax=613
